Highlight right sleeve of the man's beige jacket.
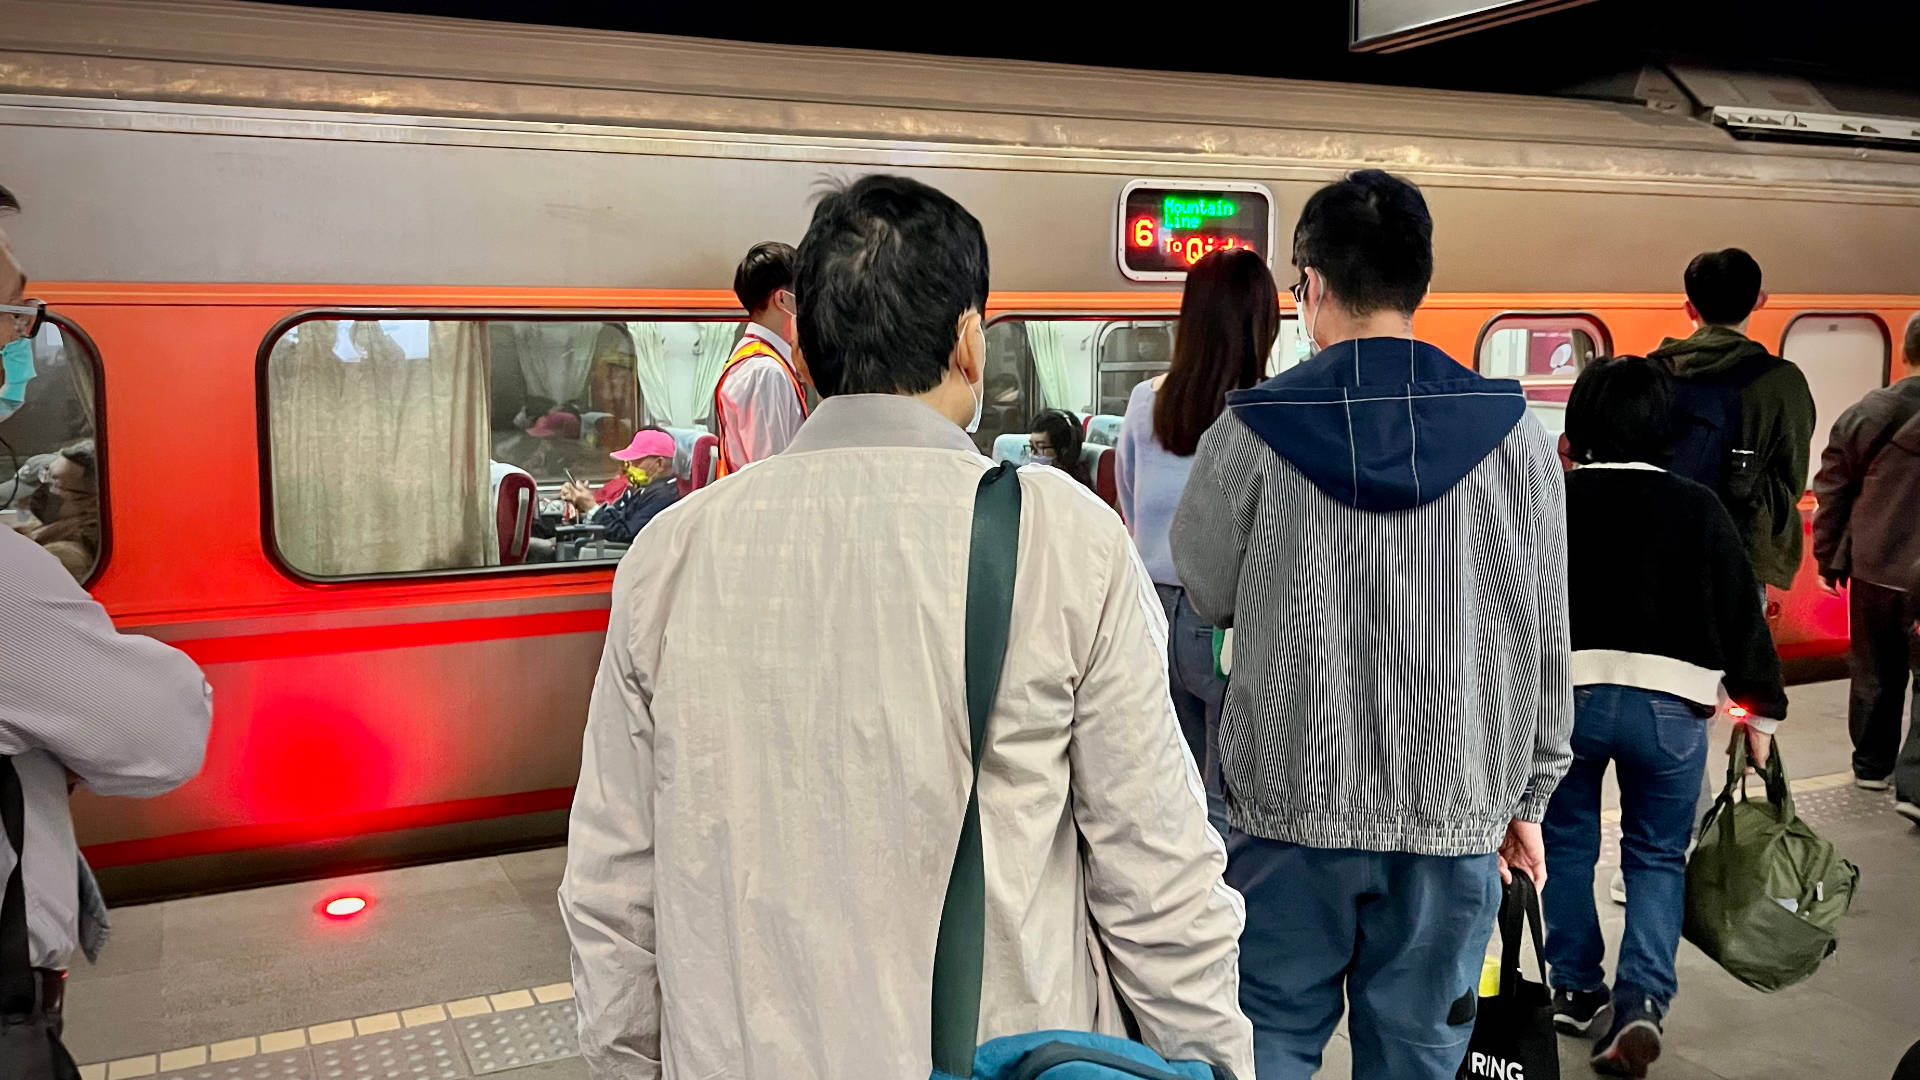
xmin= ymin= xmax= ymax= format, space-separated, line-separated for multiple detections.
xmin=1068 ymin=528 xmax=1254 ymax=1076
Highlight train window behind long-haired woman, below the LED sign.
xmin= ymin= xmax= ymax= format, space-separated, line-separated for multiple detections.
xmin=973 ymin=315 xmax=1300 ymax=454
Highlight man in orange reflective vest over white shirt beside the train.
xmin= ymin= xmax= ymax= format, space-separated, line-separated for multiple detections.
xmin=714 ymin=240 xmax=806 ymax=479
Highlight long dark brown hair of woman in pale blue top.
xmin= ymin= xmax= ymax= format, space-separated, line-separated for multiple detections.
xmin=1154 ymin=248 xmax=1281 ymax=457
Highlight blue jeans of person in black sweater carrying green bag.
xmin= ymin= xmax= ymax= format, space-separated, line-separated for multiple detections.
xmin=1540 ymin=686 xmax=1707 ymax=1011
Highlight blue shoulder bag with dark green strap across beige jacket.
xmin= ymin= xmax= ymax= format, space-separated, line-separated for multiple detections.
xmin=933 ymin=463 xmax=1233 ymax=1080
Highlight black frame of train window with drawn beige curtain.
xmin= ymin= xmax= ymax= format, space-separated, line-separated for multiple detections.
xmin=253 ymin=306 xmax=747 ymax=588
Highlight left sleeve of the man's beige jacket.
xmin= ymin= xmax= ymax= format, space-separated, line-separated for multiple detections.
xmin=561 ymin=559 xmax=660 ymax=1080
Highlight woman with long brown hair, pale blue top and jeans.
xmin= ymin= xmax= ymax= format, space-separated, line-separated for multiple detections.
xmin=1114 ymin=248 xmax=1281 ymax=834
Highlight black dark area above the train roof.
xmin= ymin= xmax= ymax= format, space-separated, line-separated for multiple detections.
xmin=284 ymin=0 xmax=1920 ymax=96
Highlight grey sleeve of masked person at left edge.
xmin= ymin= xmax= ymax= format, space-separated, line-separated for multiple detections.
xmin=0 ymin=528 xmax=213 ymax=796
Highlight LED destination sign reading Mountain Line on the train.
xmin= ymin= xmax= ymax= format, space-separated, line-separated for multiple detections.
xmin=1119 ymin=181 xmax=1273 ymax=281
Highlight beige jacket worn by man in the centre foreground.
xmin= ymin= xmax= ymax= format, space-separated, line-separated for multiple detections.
xmin=561 ymin=396 xmax=1254 ymax=1080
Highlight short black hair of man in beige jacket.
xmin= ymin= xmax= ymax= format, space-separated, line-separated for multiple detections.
xmin=793 ymin=175 xmax=987 ymax=398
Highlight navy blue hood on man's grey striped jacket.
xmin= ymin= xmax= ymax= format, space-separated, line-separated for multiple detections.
xmin=1227 ymin=338 xmax=1526 ymax=513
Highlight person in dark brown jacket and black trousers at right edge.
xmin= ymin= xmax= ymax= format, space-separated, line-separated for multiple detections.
xmin=1812 ymin=317 xmax=1920 ymax=799
